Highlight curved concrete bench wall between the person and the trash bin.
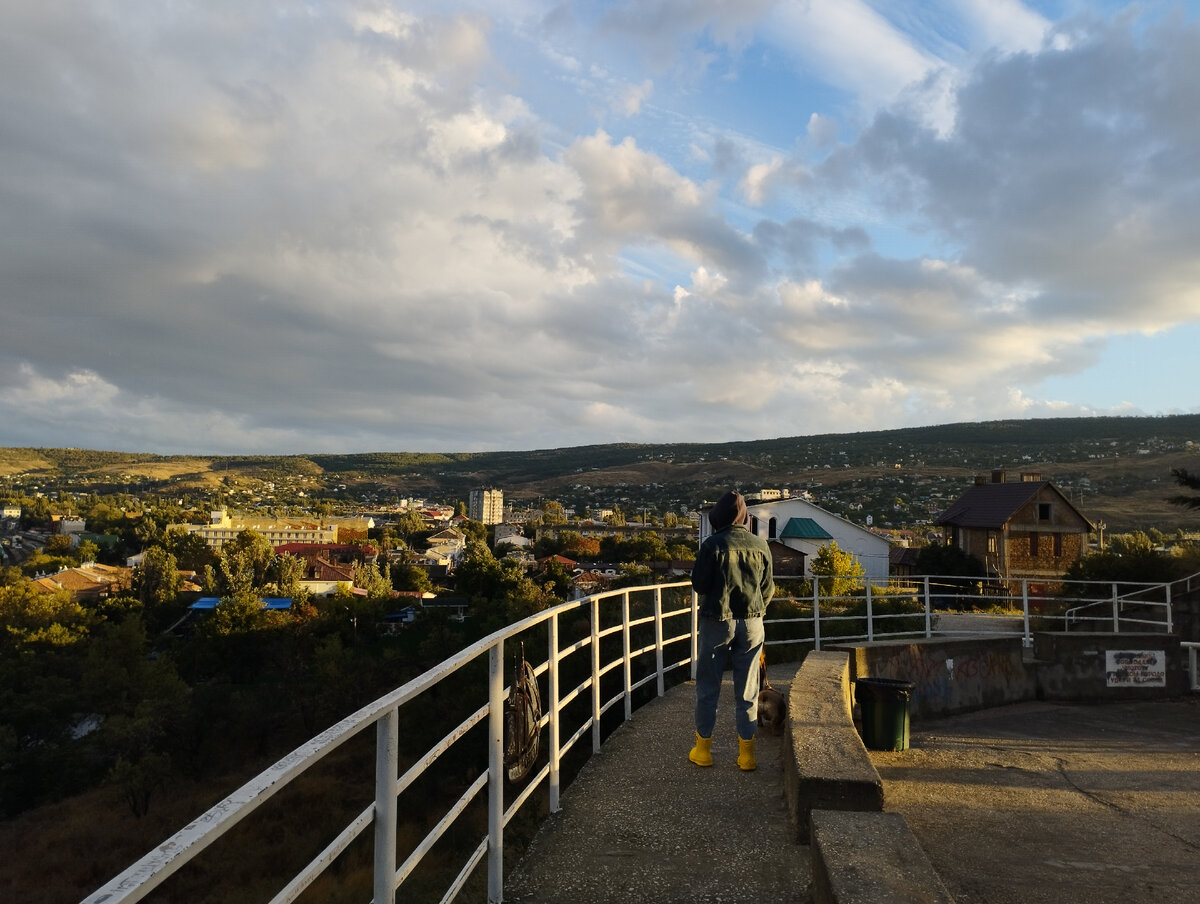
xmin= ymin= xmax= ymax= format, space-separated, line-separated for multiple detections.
xmin=784 ymin=651 xmax=883 ymax=843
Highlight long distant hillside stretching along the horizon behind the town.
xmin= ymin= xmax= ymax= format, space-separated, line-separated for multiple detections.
xmin=0 ymin=414 xmax=1200 ymax=531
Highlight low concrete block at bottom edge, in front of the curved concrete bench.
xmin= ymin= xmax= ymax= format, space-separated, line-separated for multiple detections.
xmin=812 ymin=810 xmax=954 ymax=904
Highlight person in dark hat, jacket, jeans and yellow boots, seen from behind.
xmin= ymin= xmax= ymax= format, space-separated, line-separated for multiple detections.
xmin=688 ymin=490 xmax=775 ymax=772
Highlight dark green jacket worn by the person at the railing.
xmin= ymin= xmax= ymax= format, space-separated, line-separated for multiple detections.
xmin=691 ymin=525 xmax=775 ymax=622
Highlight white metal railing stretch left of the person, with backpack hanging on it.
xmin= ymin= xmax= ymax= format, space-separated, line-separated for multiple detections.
xmin=84 ymin=581 xmax=697 ymax=904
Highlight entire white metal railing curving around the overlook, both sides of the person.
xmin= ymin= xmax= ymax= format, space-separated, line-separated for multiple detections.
xmin=82 ymin=574 xmax=1200 ymax=904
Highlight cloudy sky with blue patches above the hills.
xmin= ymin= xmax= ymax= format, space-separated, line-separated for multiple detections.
xmin=0 ymin=0 xmax=1200 ymax=455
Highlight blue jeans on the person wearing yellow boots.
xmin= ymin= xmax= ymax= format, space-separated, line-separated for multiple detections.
xmin=696 ymin=616 xmax=763 ymax=741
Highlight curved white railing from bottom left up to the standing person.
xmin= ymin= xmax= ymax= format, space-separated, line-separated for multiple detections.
xmin=82 ymin=581 xmax=697 ymax=904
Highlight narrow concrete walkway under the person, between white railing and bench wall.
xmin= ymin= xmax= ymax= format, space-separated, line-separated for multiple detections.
xmin=504 ymin=663 xmax=811 ymax=904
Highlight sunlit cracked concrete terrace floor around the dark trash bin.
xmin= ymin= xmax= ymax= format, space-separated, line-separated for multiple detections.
xmin=870 ymin=696 xmax=1200 ymax=904
